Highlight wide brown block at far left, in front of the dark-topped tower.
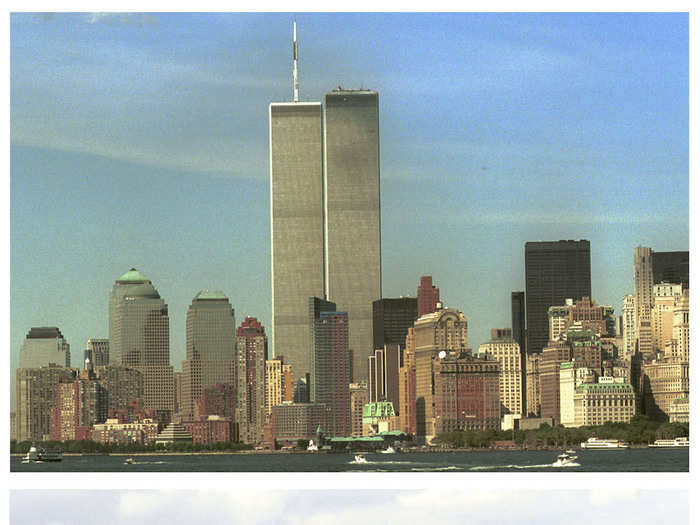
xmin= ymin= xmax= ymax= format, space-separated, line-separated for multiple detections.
xmin=15 ymin=365 xmax=76 ymax=441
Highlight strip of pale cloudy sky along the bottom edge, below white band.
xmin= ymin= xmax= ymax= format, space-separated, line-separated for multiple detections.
xmin=10 ymin=487 xmax=689 ymax=525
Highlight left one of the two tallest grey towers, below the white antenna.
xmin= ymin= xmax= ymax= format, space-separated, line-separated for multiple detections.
xmin=270 ymin=102 xmax=325 ymax=381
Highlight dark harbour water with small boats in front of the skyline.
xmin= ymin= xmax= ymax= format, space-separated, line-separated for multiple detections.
xmin=10 ymin=449 xmax=688 ymax=472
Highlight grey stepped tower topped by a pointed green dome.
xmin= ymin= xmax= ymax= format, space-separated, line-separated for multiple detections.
xmin=109 ymin=268 xmax=175 ymax=422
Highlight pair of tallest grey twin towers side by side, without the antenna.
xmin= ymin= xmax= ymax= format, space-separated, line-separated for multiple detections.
xmin=270 ymin=87 xmax=382 ymax=381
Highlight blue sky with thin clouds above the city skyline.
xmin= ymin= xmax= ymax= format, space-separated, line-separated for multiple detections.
xmin=9 ymin=13 xmax=689 ymax=392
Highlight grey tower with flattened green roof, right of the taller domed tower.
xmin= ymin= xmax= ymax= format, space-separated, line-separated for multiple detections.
xmin=180 ymin=290 xmax=236 ymax=420
